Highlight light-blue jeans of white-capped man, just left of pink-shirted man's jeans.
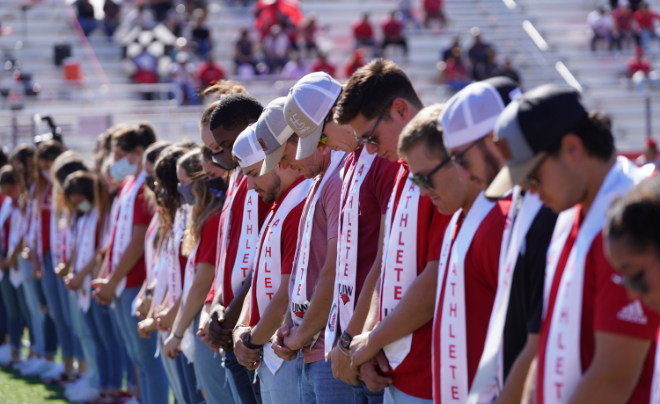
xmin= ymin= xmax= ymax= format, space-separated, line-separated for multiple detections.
xmin=257 ymin=356 xmax=302 ymax=404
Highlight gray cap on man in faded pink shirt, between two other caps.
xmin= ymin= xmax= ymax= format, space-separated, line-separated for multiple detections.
xmin=255 ymin=97 xmax=293 ymax=175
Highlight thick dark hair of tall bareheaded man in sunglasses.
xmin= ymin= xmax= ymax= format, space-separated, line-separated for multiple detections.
xmin=335 ymin=58 xmax=424 ymax=125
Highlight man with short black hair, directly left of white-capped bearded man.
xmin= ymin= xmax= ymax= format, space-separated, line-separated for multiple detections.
xmin=201 ymin=93 xmax=270 ymax=403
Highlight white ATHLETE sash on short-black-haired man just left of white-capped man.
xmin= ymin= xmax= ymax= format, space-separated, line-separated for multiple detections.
xmin=222 ymin=188 xmax=259 ymax=306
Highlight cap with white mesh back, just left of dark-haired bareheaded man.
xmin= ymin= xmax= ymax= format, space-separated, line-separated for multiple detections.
xmin=284 ymin=72 xmax=341 ymax=160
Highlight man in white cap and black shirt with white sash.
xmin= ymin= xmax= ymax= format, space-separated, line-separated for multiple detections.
xmin=440 ymin=77 xmax=557 ymax=402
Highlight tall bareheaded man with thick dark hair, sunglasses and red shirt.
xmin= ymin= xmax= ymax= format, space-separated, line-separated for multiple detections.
xmin=335 ymin=59 xmax=448 ymax=403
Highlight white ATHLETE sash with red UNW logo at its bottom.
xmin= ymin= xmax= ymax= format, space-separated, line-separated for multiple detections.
xmin=325 ymin=149 xmax=376 ymax=354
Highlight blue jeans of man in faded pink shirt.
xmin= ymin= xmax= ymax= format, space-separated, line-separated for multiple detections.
xmin=298 ymin=354 xmax=353 ymax=404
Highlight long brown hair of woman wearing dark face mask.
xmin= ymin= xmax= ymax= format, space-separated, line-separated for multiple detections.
xmin=176 ymin=148 xmax=224 ymax=255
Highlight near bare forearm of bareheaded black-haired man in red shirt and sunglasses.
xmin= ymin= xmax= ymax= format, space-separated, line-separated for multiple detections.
xmin=371 ymin=261 xmax=438 ymax=348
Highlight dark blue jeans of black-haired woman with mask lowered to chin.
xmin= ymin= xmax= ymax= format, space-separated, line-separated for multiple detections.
xmin=82 ymin=299 xmax=124 ymax=390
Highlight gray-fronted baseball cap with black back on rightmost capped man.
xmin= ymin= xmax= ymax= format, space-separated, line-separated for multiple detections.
xmin=485 ymin=84 xmax=588 ymax=198
